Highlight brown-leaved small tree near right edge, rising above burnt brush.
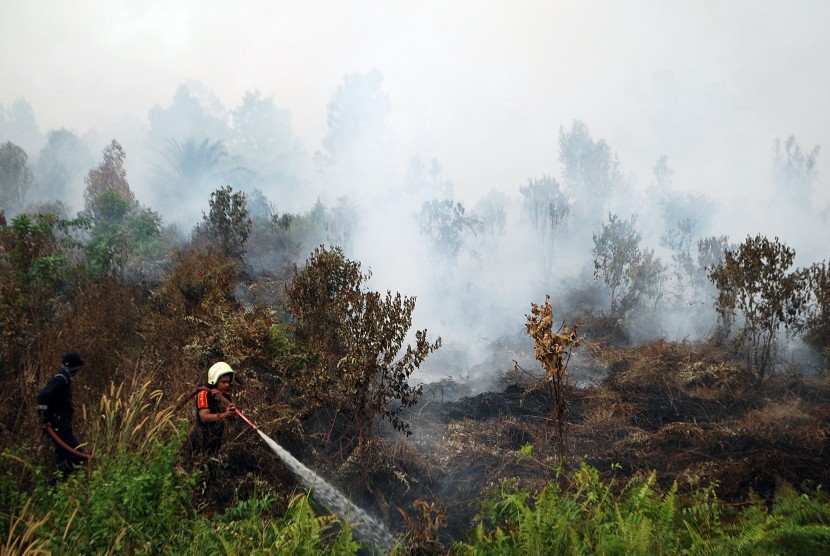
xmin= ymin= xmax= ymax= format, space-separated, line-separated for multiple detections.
xmin=709 ymin=235 xmax=807 ymax=378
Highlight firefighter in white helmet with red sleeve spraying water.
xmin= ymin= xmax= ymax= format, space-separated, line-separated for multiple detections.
xmin=189 ymin=362 xmax=236 ymax=456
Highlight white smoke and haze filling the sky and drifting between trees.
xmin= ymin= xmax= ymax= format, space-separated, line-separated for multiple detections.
xmin=0 ymin=0 xmax=830 ymax=386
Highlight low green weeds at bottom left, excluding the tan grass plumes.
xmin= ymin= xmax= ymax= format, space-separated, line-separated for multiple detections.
xmin=0 ymin=456 xmax=361 ymax=556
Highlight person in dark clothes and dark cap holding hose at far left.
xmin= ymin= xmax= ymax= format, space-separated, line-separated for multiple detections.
xmin=37 ymin=352 xmax=84 ymax=475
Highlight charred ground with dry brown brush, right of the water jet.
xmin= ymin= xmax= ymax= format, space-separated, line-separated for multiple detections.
xmin=390 ymin=336 xmax=830 ymax=535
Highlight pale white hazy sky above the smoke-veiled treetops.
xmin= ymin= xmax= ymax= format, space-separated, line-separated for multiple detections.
xmin=6 ymin=0 xmax=830 ymax=206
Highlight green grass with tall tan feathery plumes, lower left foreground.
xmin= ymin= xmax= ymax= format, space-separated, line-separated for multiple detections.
xmin=0 ymin=384 xmax=360 ymax=556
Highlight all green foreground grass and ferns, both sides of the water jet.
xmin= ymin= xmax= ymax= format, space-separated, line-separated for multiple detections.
xmin=0 ymin=384 xmax=830 ymax=556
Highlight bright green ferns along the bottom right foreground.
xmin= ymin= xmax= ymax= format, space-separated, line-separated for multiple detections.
xmin=453 ymin=464 xmax=830 ymax=555
